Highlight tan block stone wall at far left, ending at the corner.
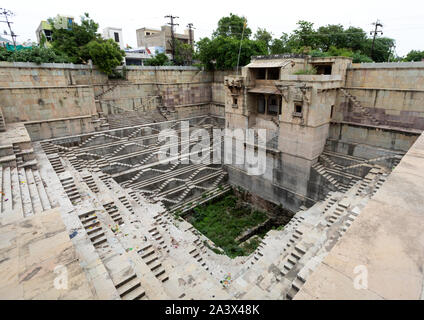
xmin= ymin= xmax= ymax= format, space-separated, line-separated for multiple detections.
xmin=0 ymin=62 xmax=104 ymax=140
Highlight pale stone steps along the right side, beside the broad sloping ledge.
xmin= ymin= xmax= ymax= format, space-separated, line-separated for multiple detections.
xmin=268 ymin=170 xmax=387 ymax=299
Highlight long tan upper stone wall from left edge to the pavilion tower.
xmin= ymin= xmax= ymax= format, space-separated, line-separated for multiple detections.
xmin=0 ymin=62 xmax=229 ymax=140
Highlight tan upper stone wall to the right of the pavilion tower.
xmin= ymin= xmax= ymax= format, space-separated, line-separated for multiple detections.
xmin=333 ymin=62 xmax=424 ymax=130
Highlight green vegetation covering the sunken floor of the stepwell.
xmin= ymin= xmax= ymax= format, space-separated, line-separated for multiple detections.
xmin=190 ymin=194 xmax=267 ymax=258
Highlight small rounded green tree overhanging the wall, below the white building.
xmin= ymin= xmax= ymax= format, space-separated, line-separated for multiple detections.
xmin=86 ymin=39 xmax=125 ymax=75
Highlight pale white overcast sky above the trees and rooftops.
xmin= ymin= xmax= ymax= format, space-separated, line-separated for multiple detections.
xmin=0 ymin=0 xmax=424 ymax=55
